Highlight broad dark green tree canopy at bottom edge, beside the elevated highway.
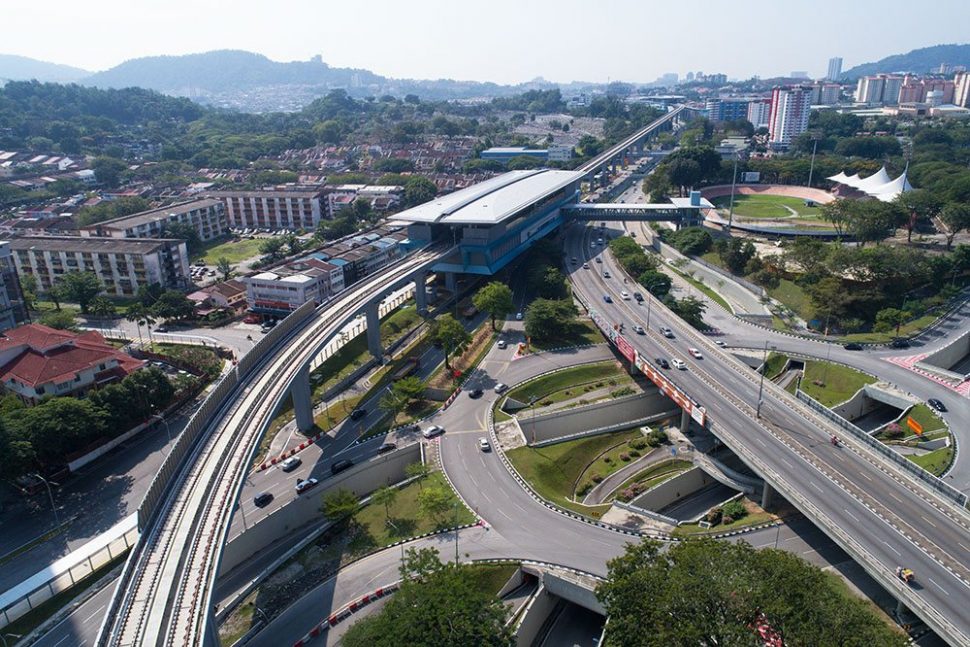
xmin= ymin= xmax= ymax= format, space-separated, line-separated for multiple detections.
xmin=596 ymin=539 xmax=907 ymax=647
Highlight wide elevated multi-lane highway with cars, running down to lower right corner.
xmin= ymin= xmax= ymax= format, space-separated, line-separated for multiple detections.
xmin=566 ymin=225 xmax=970 ymax=644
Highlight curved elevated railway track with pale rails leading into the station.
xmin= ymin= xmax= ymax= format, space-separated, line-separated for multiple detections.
xmin=99 ymin=248 xmax=444 ymax=645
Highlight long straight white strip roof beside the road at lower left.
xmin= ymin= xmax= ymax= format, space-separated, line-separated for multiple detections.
xmin=0 ymin=514 xmax=138 ymax=629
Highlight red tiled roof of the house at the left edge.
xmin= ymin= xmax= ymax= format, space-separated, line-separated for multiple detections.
xmin=0 ymin=324 xmax=145 ymax=387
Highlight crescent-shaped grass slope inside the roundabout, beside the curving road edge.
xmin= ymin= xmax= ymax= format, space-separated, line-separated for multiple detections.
xmin=506 ymin=430 xmax=641 ymax=519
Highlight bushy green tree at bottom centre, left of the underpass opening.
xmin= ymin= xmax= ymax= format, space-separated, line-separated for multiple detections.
xmin=341 ymin=548 xmax=515 ymax=647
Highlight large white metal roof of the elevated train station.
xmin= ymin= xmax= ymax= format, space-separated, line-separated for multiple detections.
xmin=394 ymin=169 xmax=583 ymax=225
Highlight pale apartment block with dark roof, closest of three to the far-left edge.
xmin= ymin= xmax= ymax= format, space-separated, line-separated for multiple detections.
xmin=10 ymin=236 xmax=190 ymax=296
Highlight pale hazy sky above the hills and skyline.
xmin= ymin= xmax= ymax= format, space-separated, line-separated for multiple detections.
xmin=7 ymin=0 xmax=970 ymax=83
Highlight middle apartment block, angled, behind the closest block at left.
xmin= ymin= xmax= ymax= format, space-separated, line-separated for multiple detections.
xmin=80 ymin=198 xmax=229 ymax=242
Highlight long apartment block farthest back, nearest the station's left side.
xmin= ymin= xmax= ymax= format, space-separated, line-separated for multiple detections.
xmin=209 ymin=190 xmax=326 ymax=231
